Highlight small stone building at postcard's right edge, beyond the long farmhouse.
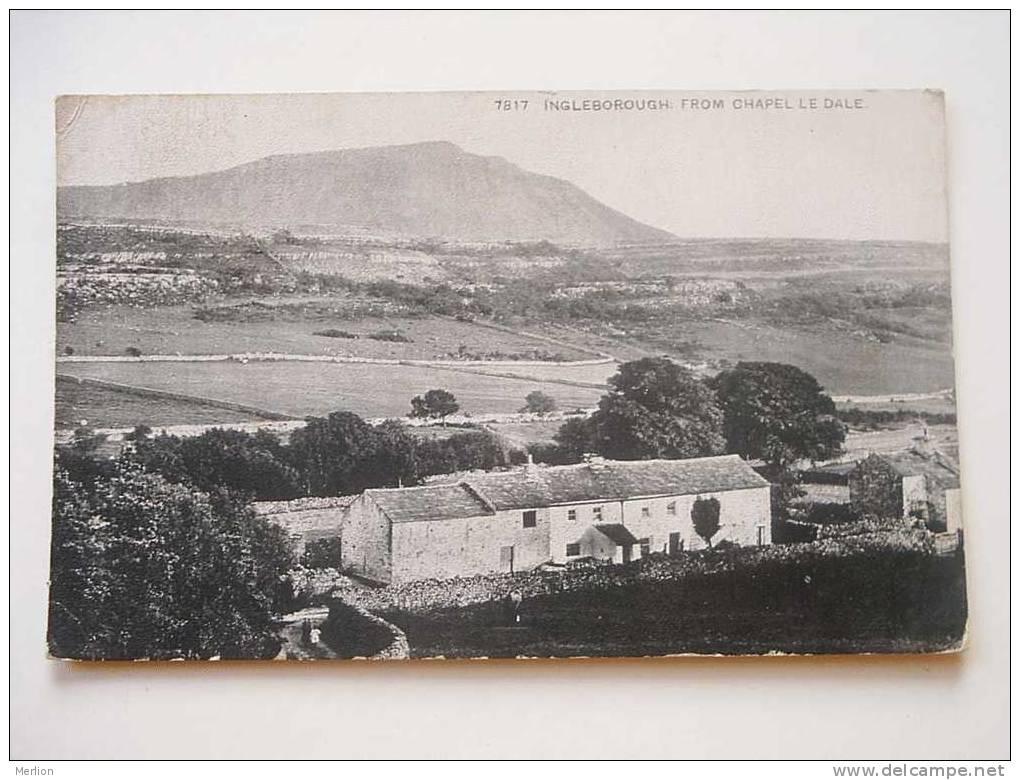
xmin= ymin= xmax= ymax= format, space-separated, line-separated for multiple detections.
xmin=850 ymin=448 xmax=962 ymax=531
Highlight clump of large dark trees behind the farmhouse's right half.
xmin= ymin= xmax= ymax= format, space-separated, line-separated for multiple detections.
xmin=531 ymin=358 xmax=846 ymax=509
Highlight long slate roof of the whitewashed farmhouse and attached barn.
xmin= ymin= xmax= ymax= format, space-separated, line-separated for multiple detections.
xmin=365 ymin=455 xmax=768 ymax=523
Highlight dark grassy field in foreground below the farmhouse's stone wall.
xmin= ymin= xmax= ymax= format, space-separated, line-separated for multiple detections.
xmin=384 ymin=553 xmax=966 ymax=658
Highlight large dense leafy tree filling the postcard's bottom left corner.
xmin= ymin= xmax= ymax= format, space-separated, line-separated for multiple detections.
xmin=49 ymin=459 xmax=293 ymax=659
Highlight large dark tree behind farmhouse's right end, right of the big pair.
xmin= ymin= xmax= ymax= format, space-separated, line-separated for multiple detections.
xmin=712 ymin=363 xmax=847 ymax=470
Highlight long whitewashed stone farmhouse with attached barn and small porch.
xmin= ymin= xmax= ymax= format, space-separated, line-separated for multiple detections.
xmin=336 ymin=455 xmax=771 ymax=582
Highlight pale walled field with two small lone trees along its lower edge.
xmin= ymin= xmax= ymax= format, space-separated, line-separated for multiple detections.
xmin=55 ymin=362 xmax=601 ymax=426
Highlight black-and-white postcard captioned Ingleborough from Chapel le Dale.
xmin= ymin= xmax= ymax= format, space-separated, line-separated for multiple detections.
xmin=48 ymin=91 xmax=967 ymax=660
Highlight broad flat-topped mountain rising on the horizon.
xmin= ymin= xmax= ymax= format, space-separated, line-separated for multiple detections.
xmin=57 ymin=142 xmax=675 ymax=245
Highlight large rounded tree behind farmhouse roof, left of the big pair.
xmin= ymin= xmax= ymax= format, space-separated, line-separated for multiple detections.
xmin=583 ymin=358 xmax=725 ymax=460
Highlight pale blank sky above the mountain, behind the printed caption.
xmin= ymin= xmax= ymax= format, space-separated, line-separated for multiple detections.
xmin=56 ymin=92 xmax=947 ymax=242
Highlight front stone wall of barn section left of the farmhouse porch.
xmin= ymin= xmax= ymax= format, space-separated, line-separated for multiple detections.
xmin=387 ymin=509 xmax=550 ymax=582
